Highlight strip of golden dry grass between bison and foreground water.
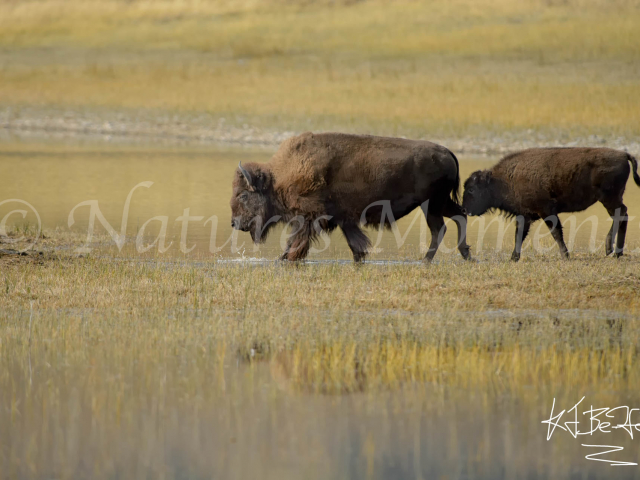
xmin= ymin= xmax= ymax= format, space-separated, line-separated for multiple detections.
xmin=0 ymin=229 xmax=640 ymax=391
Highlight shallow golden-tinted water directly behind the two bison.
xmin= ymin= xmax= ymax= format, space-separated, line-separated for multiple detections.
xmin=0 ymin=142 xmax=640 ymax=260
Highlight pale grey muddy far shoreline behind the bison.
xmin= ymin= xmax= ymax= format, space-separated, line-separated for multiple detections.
xmin=0 ymin=107 xmax=640 ymax=156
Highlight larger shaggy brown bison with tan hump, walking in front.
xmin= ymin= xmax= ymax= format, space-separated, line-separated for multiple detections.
xmin=231 ymin=133 xmax=469 ymax=262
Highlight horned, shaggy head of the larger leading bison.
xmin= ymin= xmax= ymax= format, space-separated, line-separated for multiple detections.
xmin=230 ymin=164 xmax=280 ymax=243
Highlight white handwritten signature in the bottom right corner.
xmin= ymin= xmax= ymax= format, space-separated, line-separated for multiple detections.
xmin=542 ymin=397 xmax=640 ymax=466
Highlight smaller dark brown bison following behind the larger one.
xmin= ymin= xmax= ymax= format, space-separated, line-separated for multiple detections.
xmin=462 ymin=148 xmax=640 ymax=261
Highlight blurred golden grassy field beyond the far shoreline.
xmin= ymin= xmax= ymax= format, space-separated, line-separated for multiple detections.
xmin=0 ymin=0 xmax=640 ymax=144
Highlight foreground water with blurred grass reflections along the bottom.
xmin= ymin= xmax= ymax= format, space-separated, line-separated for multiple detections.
xmin=7 ymin=347 xmax=637 ymax=479
